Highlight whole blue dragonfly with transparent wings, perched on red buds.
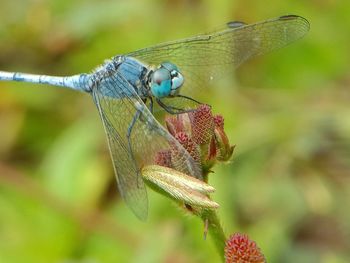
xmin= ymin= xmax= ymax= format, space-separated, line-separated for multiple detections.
xmin=0 ymin=15 xmax=309 ymax=220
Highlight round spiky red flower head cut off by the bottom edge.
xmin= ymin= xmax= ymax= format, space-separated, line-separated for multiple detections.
xmin=225 ymin=233 xmax=266 ymax=263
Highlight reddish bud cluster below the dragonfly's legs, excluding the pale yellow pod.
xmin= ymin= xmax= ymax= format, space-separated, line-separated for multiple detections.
xmin=155 ymin=104 xmax=234 ymax=178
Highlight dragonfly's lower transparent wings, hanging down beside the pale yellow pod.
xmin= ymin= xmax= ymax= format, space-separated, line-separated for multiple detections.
xmin=93 ymin=72 xmax=201 ymax=220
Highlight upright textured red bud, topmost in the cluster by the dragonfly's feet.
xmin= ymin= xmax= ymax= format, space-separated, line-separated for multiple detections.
xmin=191 ymin=104 xmax=215 ymax=145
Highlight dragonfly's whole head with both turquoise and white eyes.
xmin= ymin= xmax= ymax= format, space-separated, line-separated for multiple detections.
xmin=150 ymin=62 xmax=184 ymax=98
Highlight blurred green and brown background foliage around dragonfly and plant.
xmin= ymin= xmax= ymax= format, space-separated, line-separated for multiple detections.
xmin=0 ymin=0 xmax=350 ymax=263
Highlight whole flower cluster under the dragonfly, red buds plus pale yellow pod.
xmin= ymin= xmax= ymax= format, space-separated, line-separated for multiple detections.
xmin=146 ymin=105 xmax=234 ymax=214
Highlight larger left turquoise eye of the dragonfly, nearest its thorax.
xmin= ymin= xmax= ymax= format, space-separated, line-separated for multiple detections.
xmin=151 ymin=68 xmax=172 ymax=98
